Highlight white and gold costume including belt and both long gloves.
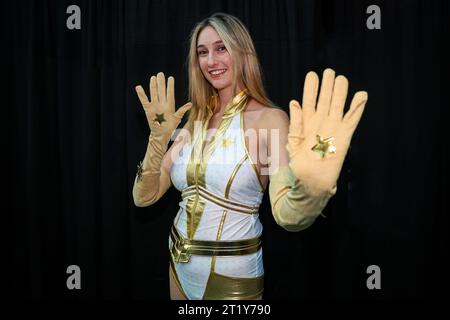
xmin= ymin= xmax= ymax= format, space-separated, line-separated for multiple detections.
xmin=133 ymin=69 xmax=368 ymax=299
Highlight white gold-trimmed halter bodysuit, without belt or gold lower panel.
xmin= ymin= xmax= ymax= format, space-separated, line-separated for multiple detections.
xmin=169 ymin=91 xmax=264 ymax=299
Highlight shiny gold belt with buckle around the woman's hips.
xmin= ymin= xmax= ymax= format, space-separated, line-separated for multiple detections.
xmin=170 ymin=225 xmax=261 ymax=263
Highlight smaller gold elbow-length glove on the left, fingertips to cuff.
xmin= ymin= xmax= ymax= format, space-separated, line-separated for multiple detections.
xmin=133 ymin=72 xmax=192 ymax=207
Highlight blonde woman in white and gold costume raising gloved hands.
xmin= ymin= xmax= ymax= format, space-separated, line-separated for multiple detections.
xmin=133 ymin=13 xmax=367 ymax=299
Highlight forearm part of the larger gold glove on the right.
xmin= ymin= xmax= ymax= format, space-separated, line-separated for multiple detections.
xmin=269 ymin=165 xmax=336 ymax=232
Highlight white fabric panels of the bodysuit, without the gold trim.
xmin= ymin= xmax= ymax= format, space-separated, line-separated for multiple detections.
xmin=169 ymin=111 xmax=264 ymax=299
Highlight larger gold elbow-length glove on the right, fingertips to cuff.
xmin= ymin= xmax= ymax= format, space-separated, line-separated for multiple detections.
xmin=269 ymin=69 xmax=368 ymax=231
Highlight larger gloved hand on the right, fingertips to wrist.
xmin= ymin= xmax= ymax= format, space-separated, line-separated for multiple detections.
xmin=286 ymin=69 xmax=368 ymax=192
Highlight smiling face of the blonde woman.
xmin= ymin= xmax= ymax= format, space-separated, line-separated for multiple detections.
xmin=197 ymin=26 xmax=233 ymax=90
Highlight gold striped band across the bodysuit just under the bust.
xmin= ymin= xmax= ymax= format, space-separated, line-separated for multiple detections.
xmin=181 ymin=185 xmax=259 ymax=214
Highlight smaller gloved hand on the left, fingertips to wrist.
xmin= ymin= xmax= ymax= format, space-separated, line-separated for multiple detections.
xmin=136 ymin=72 xmax=192 ymax=143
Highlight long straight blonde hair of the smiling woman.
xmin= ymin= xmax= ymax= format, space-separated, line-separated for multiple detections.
xmin=186 ymin=13 xmax=274 ymax=142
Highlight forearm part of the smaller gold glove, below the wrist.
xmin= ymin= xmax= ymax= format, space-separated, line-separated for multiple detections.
xmin=133 ymin=136 xmax=171 ymax=207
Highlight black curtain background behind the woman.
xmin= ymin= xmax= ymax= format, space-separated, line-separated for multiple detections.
xmin=1 ymin=0 xmax=449 ymax=300
